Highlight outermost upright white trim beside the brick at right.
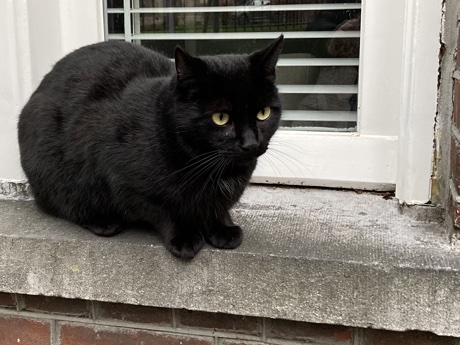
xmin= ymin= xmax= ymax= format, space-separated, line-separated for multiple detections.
xmin=396 ymin=0 xmax=442 ymax=204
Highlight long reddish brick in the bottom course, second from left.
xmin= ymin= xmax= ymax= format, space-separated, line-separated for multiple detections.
xmin=59 ymin=323 xmax=213 ymax=345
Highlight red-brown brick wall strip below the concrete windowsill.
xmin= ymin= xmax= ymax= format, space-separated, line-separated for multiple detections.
xmin=0 ymin=292 xmax=460 ymax=345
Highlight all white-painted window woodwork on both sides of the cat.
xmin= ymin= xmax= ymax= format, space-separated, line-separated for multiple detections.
xmin=0 ymin=0 xmax=442 ymax=204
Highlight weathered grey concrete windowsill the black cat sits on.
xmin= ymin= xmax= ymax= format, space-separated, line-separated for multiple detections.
xmin=0 ymin=187 xmax=460 ymax=336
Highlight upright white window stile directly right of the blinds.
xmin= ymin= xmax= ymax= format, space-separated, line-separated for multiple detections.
xmin=358 ymin=0 xmax=404 ymax=136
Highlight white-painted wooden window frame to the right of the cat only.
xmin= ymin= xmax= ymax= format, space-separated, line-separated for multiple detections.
xmin=254 ymin=0 xmax=442 ymax=204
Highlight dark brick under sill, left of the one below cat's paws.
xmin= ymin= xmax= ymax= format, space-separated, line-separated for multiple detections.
xmin=98 ymin=302 xmax=173 ymax=326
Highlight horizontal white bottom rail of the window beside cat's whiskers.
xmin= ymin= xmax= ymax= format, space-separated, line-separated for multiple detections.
xmin=253 ymin=131 xmax=398 ymax=190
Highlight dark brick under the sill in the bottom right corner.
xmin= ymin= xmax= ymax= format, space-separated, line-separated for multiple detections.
xmin=363 ymin=329 xmax=459 ymax=345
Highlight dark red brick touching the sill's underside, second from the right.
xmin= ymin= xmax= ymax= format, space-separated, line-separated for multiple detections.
xmin=269 ymin=320 xmax=352 ymax=344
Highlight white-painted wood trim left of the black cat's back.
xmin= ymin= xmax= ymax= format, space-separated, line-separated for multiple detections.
xmin=0 ymin=0 xmax=104 ymax=181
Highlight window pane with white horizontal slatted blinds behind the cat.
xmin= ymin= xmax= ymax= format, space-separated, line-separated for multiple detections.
xmin=104 ymin=0 xmax=361 ymax=132
